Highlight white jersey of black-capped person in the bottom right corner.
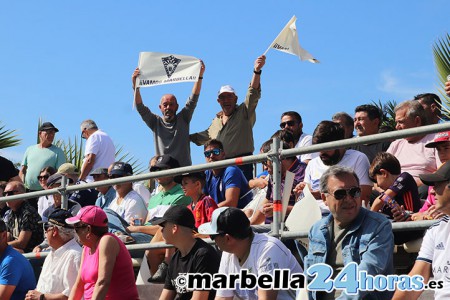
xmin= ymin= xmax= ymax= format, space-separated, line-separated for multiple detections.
xmin=417 ymin=216 xmax=450 ymax=300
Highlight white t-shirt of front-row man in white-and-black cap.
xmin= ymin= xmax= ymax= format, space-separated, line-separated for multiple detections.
xmin=216 ymin=233 xmax=303 ymax=300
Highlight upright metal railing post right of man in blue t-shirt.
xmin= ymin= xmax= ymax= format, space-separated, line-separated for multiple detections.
xmin=269 ymin=137 xmax=282 ymax=238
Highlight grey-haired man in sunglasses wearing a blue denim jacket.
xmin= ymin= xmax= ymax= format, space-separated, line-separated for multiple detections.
xmin=305 ymin=165 xmax=394 ymax=299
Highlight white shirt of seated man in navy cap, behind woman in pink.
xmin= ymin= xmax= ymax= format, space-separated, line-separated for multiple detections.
xmin=108 ymin=190 xmax=147 ymax=222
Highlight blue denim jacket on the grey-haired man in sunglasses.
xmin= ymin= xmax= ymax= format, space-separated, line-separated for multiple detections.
xmin=305 ymin=208 xmax=394 ymax=299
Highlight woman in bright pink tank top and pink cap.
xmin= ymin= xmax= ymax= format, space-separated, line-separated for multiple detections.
xmin=66 ymin=205 xmax=139 ymax=300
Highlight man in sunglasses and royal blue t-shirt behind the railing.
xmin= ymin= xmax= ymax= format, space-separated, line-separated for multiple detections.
xmin=204 ymin=140 xmax=253 ymax=208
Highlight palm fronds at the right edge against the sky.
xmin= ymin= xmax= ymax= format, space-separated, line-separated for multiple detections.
xmin=433 ymin=33 xmax=450 ymax=120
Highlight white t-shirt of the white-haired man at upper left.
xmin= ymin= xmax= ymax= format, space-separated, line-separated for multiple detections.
xmin=83 ymin=129 xmax=116 ymax=182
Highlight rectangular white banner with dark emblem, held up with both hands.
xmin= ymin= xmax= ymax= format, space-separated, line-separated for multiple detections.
xmin=136 ymin=52 xmax=201 ymax=87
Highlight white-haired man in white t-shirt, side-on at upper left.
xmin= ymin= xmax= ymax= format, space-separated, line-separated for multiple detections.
xmin=80 ymin=120 xmax=116 ymax=182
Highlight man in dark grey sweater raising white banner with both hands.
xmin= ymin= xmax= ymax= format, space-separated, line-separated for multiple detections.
xmin=132 ymin=60 xmax=205 ymax=167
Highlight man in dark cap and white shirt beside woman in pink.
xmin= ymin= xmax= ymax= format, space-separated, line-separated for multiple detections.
xmin=25 ymin=209 xmax=81 ymax=300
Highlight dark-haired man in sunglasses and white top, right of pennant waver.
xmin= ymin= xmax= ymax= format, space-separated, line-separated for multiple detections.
xmin=280 ymin=111 xmax=318 ymax=164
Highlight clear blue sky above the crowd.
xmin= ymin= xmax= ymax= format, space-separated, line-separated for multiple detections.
xmin=0 ymin=0 xmax=450 ymax=171
